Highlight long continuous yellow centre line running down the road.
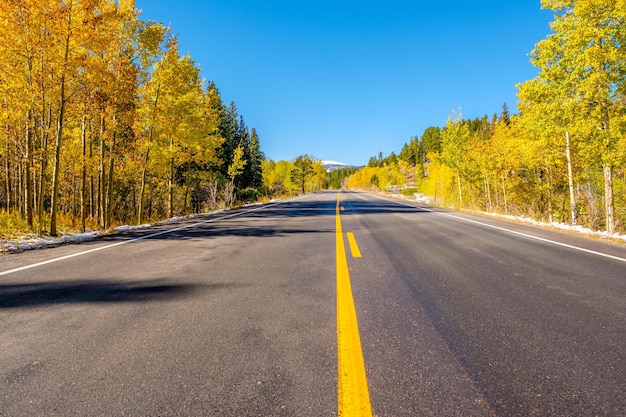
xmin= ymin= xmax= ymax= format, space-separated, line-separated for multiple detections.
xmin=335 ymin=194 xmax=372 ymax=417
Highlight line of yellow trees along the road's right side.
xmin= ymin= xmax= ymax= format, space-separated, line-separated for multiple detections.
xmin=349 ymin=0 xmax=626 ymax=234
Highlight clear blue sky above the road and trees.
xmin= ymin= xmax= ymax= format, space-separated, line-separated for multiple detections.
xmin=136 ymin=0 xmax=552 ymax=165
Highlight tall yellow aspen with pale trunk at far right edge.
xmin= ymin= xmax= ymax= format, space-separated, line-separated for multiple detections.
xmin=533 ymin=0 xmax=626 ymax=234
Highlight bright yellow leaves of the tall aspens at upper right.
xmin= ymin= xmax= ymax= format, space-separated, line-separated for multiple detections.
xmin=519 ymin=0 xmax=626 ymax=171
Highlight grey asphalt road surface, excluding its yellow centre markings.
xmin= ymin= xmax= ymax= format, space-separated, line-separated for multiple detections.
xmin=0 ymin=192 xmax=626 ymax=417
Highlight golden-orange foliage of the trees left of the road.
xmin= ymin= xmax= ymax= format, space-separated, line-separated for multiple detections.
xmin=0 ymin=0 xmax=247 ymax=228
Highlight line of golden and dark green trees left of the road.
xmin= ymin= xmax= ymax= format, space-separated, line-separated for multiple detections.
xmin=0 ymin=0 xmax=265 ymax=235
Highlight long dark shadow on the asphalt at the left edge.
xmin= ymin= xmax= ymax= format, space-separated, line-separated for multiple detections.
xmin=0 ymin=281 xmax=219 ymax=309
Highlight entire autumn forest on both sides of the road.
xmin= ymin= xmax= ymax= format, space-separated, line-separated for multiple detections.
xmin=0 ymin=0 xmax=626 ymax=237
